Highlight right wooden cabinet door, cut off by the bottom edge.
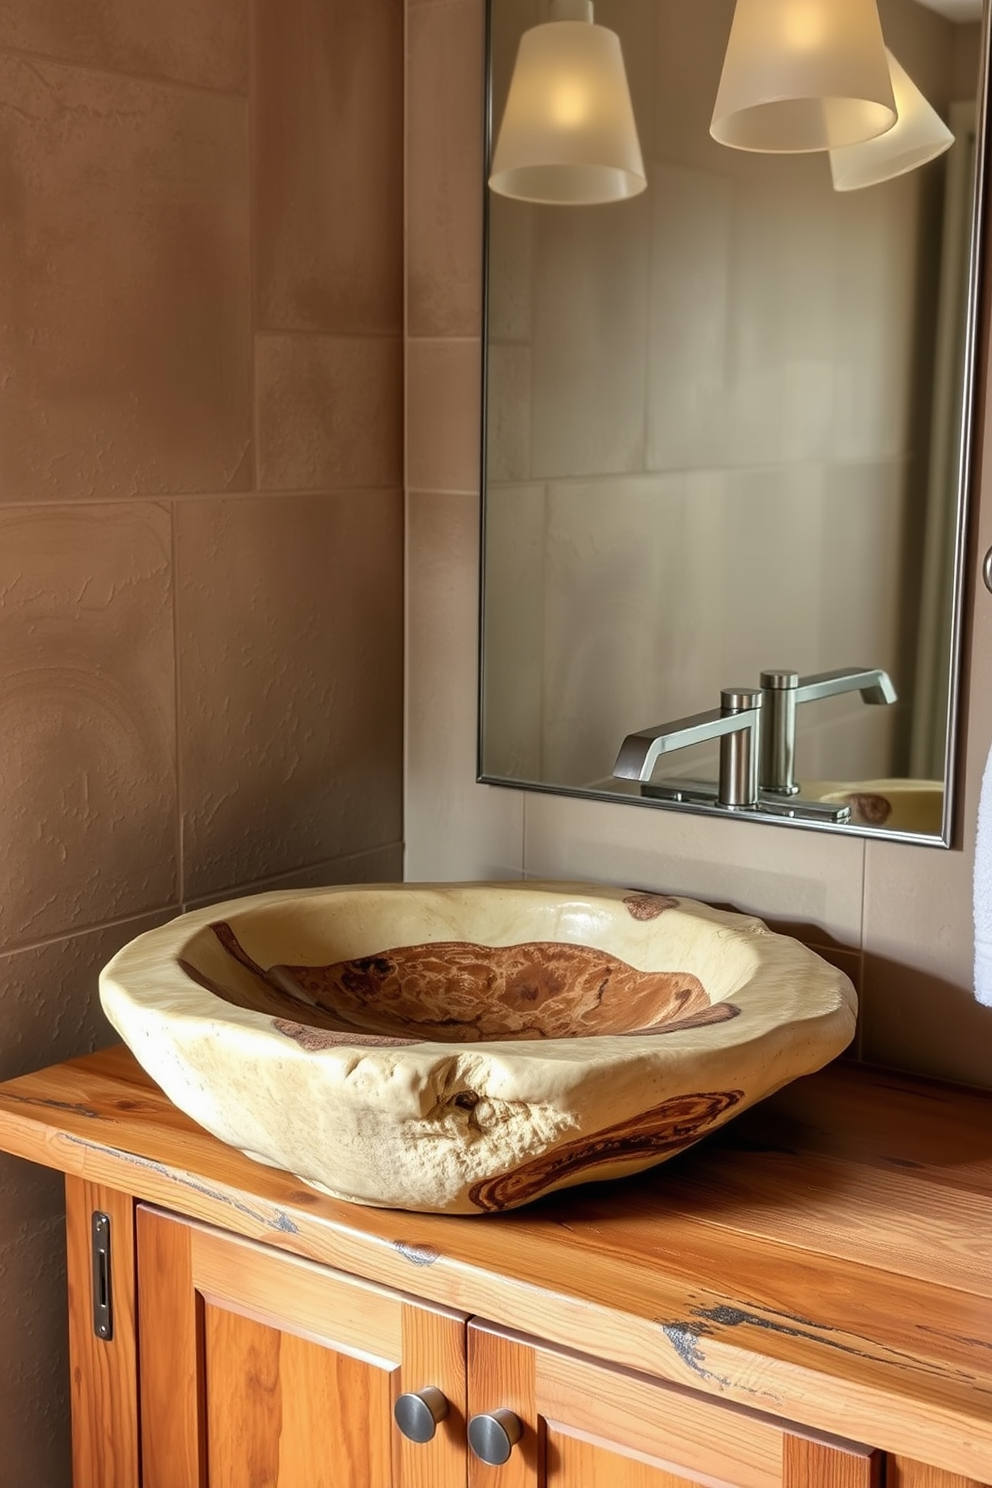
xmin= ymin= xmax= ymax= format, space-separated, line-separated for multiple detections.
xmin=468 ymin=1323 xmax=882 ymax=1488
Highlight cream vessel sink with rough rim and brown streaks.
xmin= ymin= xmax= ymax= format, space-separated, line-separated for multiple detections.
xmin=100 ymin=884 xmax=855 ymax=1214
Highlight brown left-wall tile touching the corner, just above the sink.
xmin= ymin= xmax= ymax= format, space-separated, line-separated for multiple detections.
xmin=177 ymin=491 xmax=403 ymax=899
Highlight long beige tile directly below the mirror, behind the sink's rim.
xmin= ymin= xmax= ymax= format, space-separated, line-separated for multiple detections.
xmin=524 ymin=795 xmax=864 ymax=948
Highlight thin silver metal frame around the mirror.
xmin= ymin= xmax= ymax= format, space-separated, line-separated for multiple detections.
xmin=476 ymin=0 xmax=992 ymax=848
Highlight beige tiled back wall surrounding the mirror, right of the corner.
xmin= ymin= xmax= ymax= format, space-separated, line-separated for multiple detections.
xmin=406 ymin=0 xmax=992 ymax=1086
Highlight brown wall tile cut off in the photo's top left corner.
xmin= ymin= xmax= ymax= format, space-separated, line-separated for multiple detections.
xmin=0 ymin=0 xmax=248 ymax=92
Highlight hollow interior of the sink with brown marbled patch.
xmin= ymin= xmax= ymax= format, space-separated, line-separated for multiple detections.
xmin=181 ymin=896 xmax=747 ymax=1048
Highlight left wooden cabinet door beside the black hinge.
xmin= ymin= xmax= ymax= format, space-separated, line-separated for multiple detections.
xmin=137 ymin=1205 xmax=466 ymax=1488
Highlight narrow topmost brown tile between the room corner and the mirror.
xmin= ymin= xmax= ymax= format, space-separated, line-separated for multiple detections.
xmin=406 ymin=0 xmax=485 ymax=336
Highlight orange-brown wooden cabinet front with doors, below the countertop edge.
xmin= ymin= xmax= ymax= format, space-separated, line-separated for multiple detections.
xmin=67 ymin=1180 xmax=982 ymax=1488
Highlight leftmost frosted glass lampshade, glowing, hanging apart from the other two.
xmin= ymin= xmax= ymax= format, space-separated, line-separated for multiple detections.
xmin=489 ymin=0 xmax=647 ymax=207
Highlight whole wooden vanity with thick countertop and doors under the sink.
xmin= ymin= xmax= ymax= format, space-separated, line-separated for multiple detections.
xmin=0 ymin=1051 xmax=992 ymax=1488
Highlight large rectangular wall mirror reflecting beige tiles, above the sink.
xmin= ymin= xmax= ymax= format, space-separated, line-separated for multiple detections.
xmin=479 ymin=0 xmax=988 ymax=845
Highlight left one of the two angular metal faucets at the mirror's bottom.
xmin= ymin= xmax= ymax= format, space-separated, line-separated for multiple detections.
xmin=613 ymin=687 xmax=761 ymax=809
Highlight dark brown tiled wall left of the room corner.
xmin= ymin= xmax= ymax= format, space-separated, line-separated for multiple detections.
xmin=0 ymin=0 xmax=403 ymax=1488
